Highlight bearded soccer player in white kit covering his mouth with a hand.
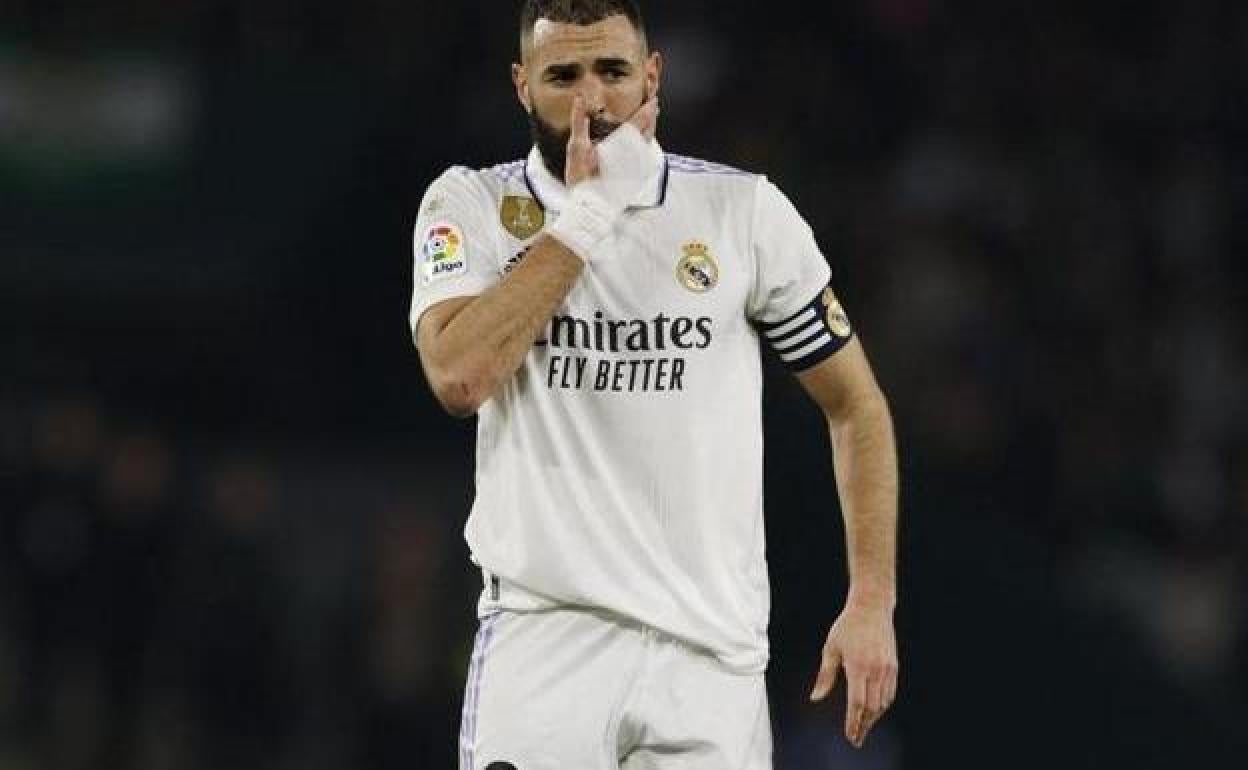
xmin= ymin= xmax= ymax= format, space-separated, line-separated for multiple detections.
xmin=411 ymin=0 xmax=897 ymax=770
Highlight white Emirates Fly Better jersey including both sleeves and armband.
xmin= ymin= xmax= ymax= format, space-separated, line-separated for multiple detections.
xmin=411 ymin=144 xmax=851 ymax=673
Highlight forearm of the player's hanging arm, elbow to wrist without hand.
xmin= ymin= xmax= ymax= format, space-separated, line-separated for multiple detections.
xmin=829 ymin=392 xmax=897 ymax=609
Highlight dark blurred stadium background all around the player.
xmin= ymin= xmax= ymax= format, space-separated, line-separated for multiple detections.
xmin=0 ymin=0 xmax=1248 ymax=770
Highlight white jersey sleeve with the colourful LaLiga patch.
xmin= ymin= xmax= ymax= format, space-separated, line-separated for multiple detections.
xmin=408 ymin=167 xmax=500 ymax=349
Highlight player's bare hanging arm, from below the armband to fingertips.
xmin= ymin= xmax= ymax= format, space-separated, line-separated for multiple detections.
xmin=797 ymin=338 xmax=899 ymax=746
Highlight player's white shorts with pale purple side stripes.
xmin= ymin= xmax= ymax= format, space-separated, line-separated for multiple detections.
xmin=459 ymin=609 xmax=771 ymax=770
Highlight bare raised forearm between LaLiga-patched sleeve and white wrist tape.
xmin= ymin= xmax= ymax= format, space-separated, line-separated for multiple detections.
xmin=438 ymin=237 xmax=584 ymax=403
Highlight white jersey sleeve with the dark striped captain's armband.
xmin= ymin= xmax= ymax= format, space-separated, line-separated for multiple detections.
xmin=748 ymin=178 xmax=854 ymax=372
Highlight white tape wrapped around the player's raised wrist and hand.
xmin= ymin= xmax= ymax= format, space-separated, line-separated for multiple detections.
xmin=547 ymin=124 xmax=654 ymax=262
